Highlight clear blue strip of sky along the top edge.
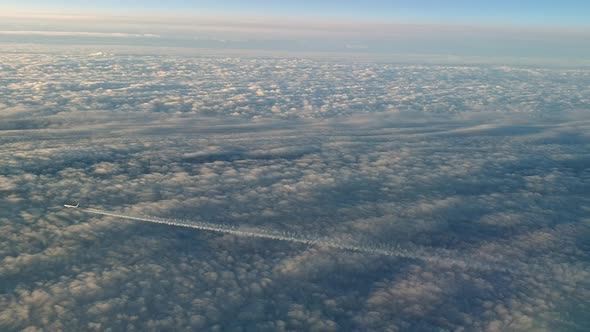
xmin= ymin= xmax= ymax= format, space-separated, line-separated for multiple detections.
xmin=6 ymin=0 xmax=590 ymax=26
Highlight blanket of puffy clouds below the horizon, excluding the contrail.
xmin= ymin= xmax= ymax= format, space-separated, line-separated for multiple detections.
xmin=0 ymin=51 xmax=590 ymax=331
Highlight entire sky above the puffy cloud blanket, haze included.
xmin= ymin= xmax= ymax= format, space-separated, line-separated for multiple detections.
xmin=0 ymin=0 xmax=590 ymax=66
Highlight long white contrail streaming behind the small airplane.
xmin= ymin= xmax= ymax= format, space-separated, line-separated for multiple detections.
xmin=73 ymin=206 xmax=507 ymax=271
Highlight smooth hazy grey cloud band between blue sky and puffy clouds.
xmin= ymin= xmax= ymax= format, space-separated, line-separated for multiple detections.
xmin=0 ymin=12 xmax=590 ymax=67
